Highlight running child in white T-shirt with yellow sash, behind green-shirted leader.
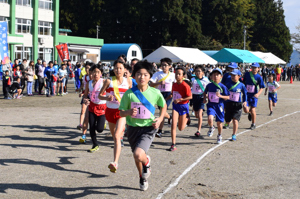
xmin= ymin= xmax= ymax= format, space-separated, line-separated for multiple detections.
xmin=150 ymin=57 xmax=176 ymax=138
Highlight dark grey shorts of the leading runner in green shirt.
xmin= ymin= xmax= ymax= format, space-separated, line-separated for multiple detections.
xmin=127 ymin=126 xmax=156 ymax=153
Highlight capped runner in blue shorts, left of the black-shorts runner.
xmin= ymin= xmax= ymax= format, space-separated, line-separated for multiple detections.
xmin=203 ymin=68 xmax=229 ymax=144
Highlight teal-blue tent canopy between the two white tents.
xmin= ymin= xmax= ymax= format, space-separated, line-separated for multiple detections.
xmin=212 ymin=48 xmax=265 ymax=63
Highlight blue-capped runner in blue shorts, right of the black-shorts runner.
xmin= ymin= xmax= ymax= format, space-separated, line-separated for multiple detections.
xmin=243 ymin=63 xmax=265 ymax=130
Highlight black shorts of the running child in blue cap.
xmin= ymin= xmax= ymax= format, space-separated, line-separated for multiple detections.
xmin=225 ymin=101 xmax=243 ymax=122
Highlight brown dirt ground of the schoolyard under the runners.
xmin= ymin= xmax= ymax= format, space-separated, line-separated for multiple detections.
xmin=0 ymin=82 xmax=300 ymax=199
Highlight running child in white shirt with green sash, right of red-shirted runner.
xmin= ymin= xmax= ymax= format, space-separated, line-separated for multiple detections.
xmin=191 ymin=65 xmax=210 ymax=139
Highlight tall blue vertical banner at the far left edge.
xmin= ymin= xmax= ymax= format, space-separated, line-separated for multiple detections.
xmin=0 ymin=21 xmax=10 ymax=64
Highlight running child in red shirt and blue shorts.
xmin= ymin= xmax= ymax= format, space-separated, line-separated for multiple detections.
xmin=166 ymin=67 xmax=192 ymax=151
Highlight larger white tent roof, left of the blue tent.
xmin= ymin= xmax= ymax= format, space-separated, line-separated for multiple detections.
xmin=144 ymin=46 xmax=218 ymax=64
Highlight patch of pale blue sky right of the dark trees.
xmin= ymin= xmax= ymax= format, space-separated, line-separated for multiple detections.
xmin=282 ymin=0 xmax=300 ymax=33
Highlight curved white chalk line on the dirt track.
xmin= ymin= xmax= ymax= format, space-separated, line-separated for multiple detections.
xmin=156 ymin=111 xmax=300 ymax=199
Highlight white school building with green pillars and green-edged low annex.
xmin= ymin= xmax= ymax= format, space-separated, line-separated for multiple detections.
xmin=0 ymin=0 xmax=104 ymax=63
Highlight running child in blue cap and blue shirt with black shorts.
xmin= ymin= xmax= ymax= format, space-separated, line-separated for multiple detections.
xmin=224 ymin=69 xmax=247 ymax=141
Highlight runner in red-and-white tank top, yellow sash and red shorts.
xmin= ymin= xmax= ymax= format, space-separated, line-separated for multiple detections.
xmin=99 ymin=60 xmax=132 ymax=173
